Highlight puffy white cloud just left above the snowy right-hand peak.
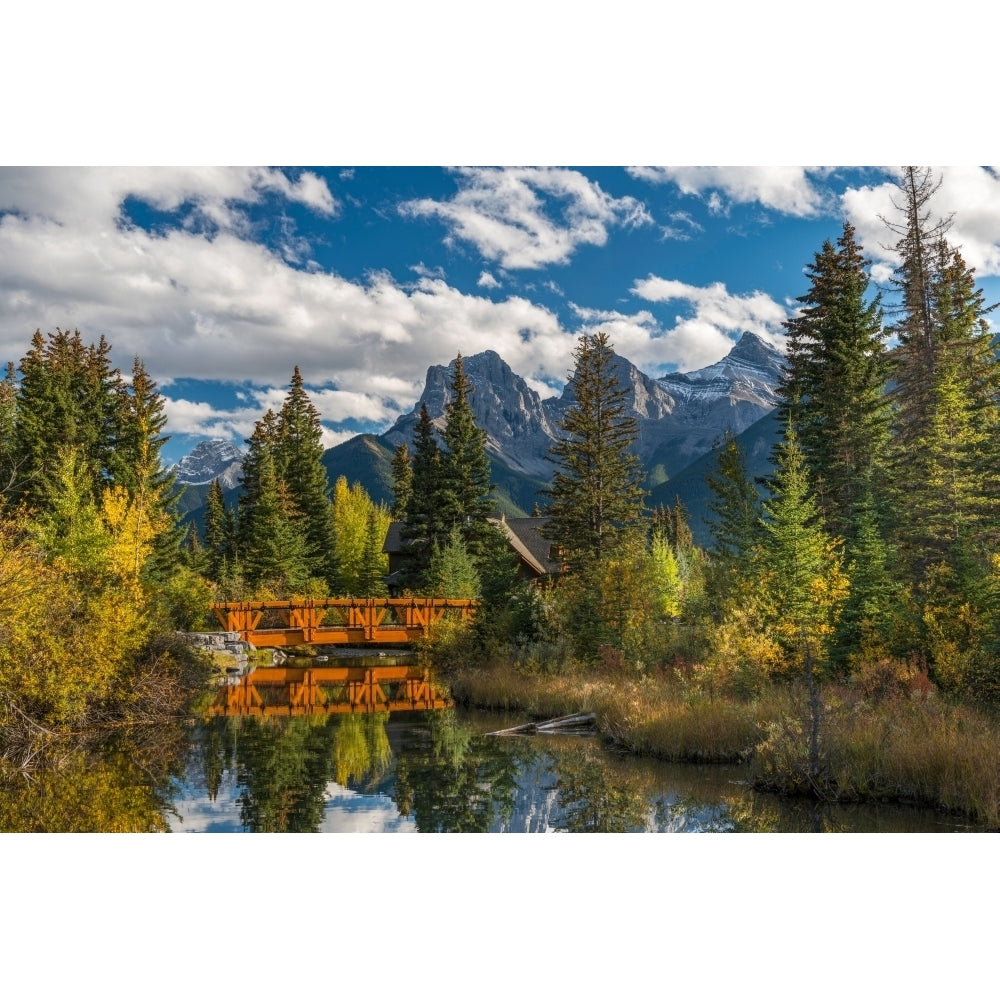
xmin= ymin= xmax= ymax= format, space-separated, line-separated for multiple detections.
xmin=632 ymin=275 xmax=788 ymax=371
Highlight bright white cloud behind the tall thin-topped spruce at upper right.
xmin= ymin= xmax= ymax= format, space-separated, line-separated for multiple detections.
xmin=841 ymin=167 xmax=1000 ymax=281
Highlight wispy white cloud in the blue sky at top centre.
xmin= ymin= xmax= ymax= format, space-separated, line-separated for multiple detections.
xmin=399 ymin=167 xmax=652 ymax=270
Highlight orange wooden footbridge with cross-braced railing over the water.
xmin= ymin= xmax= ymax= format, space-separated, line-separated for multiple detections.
xmin=212 ymin=597 xmax=477 ymax=647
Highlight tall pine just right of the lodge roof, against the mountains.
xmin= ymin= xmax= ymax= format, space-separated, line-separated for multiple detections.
xmin=545 ymin=333 xmax=645 ymax=568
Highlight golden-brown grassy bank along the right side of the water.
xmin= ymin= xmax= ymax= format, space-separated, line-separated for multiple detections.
xmin=449 ymin=663 xmax=1000 ymax=829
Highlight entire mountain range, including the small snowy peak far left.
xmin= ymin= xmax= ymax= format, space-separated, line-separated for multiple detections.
xmin=175 ymin=333 xmax=784 ymax=514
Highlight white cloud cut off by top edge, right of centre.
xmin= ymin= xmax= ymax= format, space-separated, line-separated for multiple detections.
xmin=628 ymin=167 xmax=828 ymax=216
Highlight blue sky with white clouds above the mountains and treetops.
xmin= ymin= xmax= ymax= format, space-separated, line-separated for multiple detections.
xmin=0 ymin=166 xmax=1000 ymax=460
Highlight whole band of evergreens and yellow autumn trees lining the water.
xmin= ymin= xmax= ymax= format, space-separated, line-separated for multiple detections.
xmin=0 ymin=168 xmax=1000 ymax=784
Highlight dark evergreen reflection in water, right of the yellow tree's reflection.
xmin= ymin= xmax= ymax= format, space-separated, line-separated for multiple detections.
xmin=392 ymin=710 xmax=534 ymax=833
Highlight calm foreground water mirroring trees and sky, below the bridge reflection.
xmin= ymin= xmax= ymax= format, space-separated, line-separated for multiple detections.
xmin=0 ymin=692 xmax=968 ymax=833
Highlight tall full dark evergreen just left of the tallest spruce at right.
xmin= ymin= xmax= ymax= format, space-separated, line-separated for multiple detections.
xmin=778 ymin=222 xmax=890 ymax=538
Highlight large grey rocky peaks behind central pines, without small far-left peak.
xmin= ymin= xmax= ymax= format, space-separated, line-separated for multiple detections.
xmin=382 ymin=332 xmax=784 ymax=483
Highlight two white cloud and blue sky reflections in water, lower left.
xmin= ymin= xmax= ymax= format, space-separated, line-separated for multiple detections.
xmin=167 ymin=775 xmax=416 ymax=833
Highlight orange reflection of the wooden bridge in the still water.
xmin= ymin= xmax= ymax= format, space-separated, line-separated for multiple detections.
xmin=207 ymin=664 xmax=452 ymax=716
